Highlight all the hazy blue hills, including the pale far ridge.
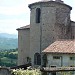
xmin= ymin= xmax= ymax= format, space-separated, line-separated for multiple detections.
xmin=0 ymin=33 xmax=18 ymax=50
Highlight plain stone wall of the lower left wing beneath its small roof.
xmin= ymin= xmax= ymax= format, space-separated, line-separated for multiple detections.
xmin=18 ymin=29 xmax=30 ymax=65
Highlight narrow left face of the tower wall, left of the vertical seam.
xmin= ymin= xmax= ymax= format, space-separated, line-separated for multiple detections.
xmin=30 ymin=5 xmax=41 ymax=64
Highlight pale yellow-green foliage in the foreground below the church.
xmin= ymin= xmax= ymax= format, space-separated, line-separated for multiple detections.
xmin=12 ymin=69 xmax=42 ymax=75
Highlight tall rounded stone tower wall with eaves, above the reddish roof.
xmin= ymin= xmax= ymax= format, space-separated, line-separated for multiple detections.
xmin=29 ymin=1 xmax=72 ymax=64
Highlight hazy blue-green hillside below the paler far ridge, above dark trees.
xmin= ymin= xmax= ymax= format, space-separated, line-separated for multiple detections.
xmin=0 ymin=37 xmax=18 ymax=51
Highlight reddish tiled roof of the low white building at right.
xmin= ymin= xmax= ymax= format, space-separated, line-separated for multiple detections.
xmin=43 ymin=40 xmax=75 ymax=54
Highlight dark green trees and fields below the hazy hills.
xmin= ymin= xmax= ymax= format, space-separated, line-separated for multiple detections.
xmin=0 ymin=49 xmax=18 ymax=67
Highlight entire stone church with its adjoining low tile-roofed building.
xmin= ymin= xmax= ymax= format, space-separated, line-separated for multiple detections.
xmin=17 ymin=0 xmax=75 ymax=67
